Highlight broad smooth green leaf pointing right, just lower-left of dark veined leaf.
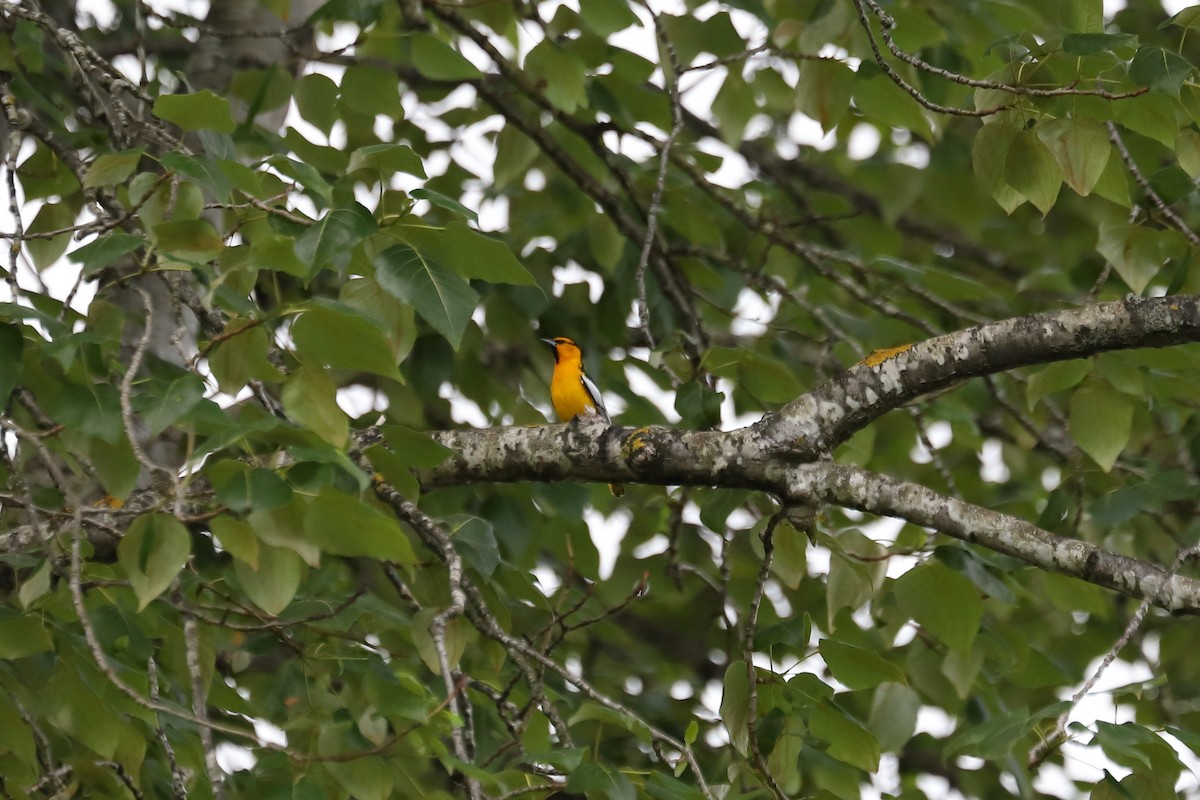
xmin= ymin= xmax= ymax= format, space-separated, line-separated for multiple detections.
xmin=292 ymin=303 xmax=400 ymax=380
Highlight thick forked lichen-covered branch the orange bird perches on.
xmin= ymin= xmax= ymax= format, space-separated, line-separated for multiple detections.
xmin=418 ymin=296 xmax=1200 ymax=612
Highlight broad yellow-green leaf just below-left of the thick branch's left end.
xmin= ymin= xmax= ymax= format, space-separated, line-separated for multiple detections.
xmin=304 ymin=487 xmax=416 ymax=566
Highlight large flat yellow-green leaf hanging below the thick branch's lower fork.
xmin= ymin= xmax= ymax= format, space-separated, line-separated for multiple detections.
xmin=893 ymin=561 xmax=983 ymax=655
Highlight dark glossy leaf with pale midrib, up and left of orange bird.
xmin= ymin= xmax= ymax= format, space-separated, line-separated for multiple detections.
xmin=374 ymin=245 xmax=479 ymax=350
